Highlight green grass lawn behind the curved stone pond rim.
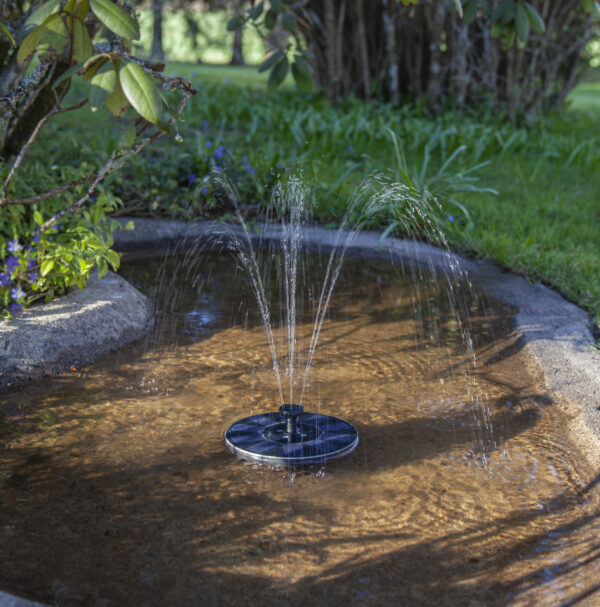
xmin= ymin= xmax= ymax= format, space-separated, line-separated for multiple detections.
xmin=32 ymin=63 xmax=600 ymax=322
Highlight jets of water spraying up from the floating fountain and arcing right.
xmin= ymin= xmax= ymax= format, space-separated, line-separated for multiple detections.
xmin=213 ymin=176 xmax=495 ymax=466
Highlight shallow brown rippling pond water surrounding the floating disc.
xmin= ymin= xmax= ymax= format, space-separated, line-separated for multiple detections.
xmin=0 ymin=257 xmax=600 ymax=606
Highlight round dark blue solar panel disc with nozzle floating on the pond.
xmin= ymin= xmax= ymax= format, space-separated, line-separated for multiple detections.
xmin=225 ymin=405 xmax=358 ymax=466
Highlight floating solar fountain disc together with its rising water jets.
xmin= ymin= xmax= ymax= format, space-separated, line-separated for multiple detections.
xmin=220 ymin=179 xmax=367 ymax=467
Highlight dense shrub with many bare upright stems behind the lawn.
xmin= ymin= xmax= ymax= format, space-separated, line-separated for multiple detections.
xmin=241 ymin=0 xmax=600 ymax=114
